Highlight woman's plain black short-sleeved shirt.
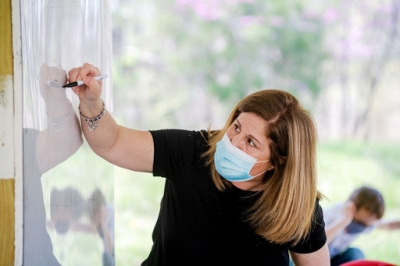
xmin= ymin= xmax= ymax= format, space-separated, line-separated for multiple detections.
xmin=142 ymin=130 xmax=326 ymax=266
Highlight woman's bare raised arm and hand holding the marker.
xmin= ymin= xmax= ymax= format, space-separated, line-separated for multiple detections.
xmin=69 ymin=64 xmax=154 ymax=172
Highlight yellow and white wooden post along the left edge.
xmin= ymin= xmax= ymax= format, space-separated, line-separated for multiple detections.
xmin=0 ymin=0 xmax=15 ymax=265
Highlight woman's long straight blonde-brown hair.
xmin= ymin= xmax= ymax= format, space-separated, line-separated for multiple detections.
xmin=204 ymin=90 xmax=322 ymax=244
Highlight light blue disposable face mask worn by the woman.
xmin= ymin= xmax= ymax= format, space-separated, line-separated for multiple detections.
xmin=214 ymin=134 xmax=269 ymax=182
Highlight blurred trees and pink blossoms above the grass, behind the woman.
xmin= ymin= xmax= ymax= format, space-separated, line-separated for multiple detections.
xmin=113 ymin=0 xmax=400 ymax=140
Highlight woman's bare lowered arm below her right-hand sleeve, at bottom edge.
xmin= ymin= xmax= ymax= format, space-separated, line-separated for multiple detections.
xmin=289 ymin=243 xmax=330 ymax=266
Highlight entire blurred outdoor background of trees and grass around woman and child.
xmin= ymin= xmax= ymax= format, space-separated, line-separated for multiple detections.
xmin=106 ymin=0 xmax=400 ymax=265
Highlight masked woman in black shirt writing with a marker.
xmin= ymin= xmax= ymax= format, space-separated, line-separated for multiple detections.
xmin=69 ymin=64 xmax=329 ymax=266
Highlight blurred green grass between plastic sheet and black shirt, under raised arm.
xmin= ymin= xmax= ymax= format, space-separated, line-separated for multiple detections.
xmin=115 ymin=168 xmax=164 ymax=265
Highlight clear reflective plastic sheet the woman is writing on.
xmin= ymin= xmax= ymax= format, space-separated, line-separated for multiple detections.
xmin=20 ymin=0 xmax=115 ymax=265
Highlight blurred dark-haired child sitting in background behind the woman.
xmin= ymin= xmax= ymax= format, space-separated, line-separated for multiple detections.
xmin=324 ymin=186 xmax=399 ymax=266
